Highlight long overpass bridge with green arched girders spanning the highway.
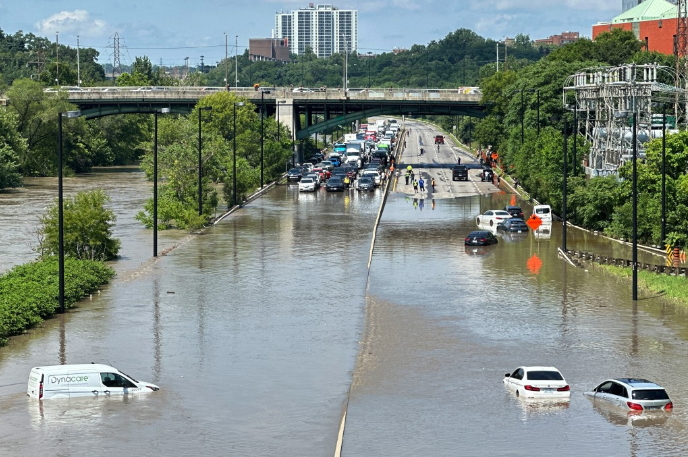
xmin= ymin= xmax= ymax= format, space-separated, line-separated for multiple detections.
xmin=47 ymin=87 xmax=485 ymax=140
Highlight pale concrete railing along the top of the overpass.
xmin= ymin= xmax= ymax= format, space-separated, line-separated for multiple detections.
xmin=53 ymin=86 xmax=482 ymax=102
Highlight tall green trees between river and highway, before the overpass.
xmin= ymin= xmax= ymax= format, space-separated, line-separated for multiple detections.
xmin=137 ymin=92 xmax=291 ymax=229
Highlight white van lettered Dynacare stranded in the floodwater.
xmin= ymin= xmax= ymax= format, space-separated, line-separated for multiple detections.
xmin=26 ymin=363 xmax=160 ymax=400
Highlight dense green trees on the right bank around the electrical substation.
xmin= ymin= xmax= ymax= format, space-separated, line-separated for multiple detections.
xmin=438 ymin=29 xmax=688 ymax=246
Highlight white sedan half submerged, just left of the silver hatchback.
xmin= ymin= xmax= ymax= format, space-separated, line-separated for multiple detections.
xmin=504 ymin=367 xmax=571 ymax=400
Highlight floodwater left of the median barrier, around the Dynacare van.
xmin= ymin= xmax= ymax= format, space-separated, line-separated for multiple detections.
xmin=0 ymin=171 xmax=380 ymax=456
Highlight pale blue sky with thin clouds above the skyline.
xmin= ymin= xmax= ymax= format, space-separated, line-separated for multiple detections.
xmin=0 ymin=0 xmax=621 ymax=66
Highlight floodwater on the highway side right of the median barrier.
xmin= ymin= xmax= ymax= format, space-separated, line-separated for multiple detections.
xmin=342 ymin=190 xmax=688 ymax=456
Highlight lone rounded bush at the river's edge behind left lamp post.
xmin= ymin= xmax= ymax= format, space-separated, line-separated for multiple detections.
xmin=35 ymin=189 xmax=120 ymax=260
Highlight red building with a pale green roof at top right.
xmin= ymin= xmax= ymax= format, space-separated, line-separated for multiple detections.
xmin=592 ymin=0 xmax=677 ymax=54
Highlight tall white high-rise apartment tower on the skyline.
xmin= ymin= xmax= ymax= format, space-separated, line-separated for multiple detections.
xmin=275 ymin=3 xmax=358 ymax=57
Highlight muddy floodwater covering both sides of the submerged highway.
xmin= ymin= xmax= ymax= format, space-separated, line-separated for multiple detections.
xmin=0 ymin=124 xmax=688 ymax=456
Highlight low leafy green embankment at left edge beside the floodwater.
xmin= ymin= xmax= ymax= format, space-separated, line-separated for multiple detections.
xmin=0 ymin=259 xmax=115 ymax=346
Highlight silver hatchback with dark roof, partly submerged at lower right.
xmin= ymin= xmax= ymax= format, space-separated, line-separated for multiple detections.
xmin=584 ymin=378 xmax=674 ymax=412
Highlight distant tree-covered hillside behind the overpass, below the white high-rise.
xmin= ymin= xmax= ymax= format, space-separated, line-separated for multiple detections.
xmin=199 ymin=29 xmax=549 ymax=88
